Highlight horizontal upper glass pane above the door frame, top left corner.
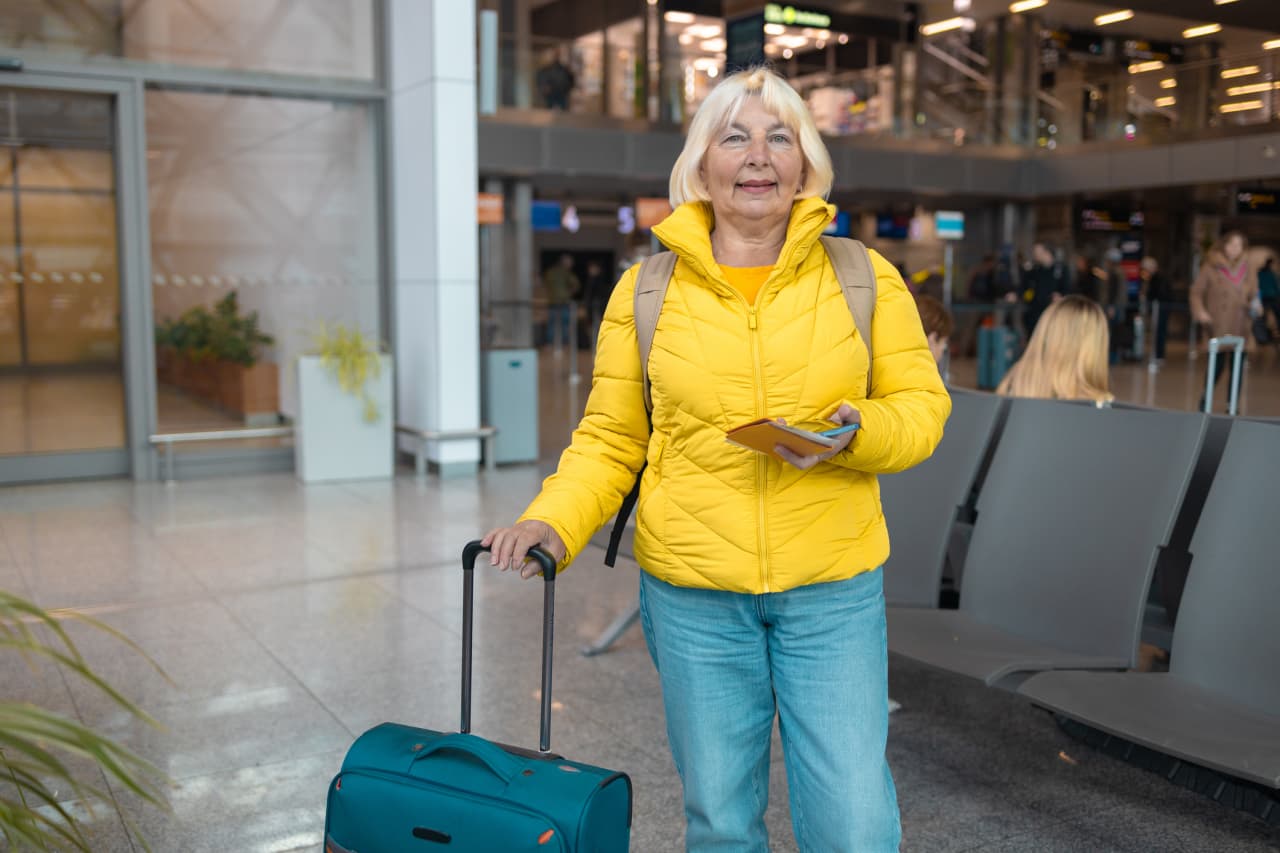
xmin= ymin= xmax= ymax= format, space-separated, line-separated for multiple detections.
xmin=0 ymin=0 xmax=375 ymax=79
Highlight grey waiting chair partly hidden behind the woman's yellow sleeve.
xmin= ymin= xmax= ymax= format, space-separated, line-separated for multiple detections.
xmin=879 ymin=389 xmax=1009 ymax=607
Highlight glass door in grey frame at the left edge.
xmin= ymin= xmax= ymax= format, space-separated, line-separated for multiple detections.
xmin=0 ymin=86 xmax=129 ymax=482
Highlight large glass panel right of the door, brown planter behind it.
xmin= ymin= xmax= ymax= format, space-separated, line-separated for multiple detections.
xmin=146 ymin=90 xmax=373 ymax=432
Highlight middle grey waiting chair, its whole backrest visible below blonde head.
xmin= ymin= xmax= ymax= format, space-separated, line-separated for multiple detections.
xmin=888 ymin=400 xmax=1207 ymax=686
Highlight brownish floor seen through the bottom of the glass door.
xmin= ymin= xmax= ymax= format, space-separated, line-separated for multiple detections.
xmin=0 ymin=370 xmax=124 ymax=456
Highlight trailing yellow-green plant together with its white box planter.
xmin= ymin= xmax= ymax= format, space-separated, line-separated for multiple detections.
xmin=293 ymin=324 xmax=394 ymax=483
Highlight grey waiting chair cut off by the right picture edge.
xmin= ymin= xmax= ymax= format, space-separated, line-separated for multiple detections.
xmin=1019 ymin=420 xmax=1280 ymax=789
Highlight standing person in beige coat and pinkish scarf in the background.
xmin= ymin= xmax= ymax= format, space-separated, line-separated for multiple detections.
xmin=1190 ymin=231 xmax=1260 ymax=409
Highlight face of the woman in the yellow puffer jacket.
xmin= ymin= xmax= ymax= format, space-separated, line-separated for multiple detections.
xmin=699 ymin=97 xmax=804 ymax=222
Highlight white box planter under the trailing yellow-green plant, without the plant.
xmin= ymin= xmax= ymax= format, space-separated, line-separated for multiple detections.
xmin=293 ymin=356 xmax=396 ymax=483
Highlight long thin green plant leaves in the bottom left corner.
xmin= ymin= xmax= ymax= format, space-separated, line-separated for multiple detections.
xmin=0 ymin=590 xmax=168 ymax=853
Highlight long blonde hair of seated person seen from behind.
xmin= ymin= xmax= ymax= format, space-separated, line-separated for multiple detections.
xmin=996 ymin=296 xmax=1114 ymax=402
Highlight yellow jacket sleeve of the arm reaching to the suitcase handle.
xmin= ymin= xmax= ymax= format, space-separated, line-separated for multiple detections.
xmin=520 ymin=268 xmax=650 ymax=565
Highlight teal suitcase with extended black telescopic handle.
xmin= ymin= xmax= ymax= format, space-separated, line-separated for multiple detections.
xmin=324 ymin=542 xmax=631 ymax=853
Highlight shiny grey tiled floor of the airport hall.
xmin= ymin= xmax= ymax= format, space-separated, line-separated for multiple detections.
xmin=0 ymin=466 xmax=1280 ymax=853
